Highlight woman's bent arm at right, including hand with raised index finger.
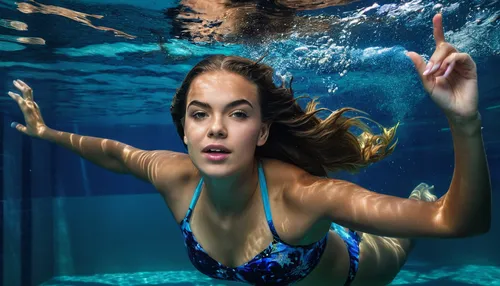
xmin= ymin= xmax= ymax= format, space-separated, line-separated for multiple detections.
xmin=289 ymin=14 xmax=491 ymax=237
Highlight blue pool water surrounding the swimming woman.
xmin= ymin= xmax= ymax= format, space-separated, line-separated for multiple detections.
xmin=0 ymin=0 xmax=500 ymax=286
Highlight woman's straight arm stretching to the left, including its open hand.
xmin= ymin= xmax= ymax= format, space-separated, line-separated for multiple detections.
xmin=9 ymin=80 xmax=191 ymax=190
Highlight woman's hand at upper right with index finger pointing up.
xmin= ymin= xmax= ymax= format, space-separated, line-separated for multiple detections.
xmin=407 ymin=14 xmax=478 ymax=123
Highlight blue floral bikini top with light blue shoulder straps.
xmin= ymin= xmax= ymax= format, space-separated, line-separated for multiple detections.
xmin=180 ymin=162 xmax=327 ymax=285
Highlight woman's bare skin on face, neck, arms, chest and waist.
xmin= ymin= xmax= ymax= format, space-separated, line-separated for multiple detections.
xmin=9 ymin=15 xmax=491 ymax=285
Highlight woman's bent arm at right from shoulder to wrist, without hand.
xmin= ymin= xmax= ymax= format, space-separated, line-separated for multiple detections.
xmin=287 ymin=115 xmax=491 ymax=238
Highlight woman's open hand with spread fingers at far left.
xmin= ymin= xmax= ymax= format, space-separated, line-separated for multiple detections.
xmin=9 ymin=79 xmax=47 ymax=138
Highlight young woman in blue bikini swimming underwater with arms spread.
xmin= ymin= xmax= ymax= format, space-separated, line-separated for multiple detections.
xmin=9 ymin=15 xmax=491 ymax=285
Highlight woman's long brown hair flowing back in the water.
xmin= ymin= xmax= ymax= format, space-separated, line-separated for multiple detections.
xmin=170 ymin=55 xmax=397 ymax=176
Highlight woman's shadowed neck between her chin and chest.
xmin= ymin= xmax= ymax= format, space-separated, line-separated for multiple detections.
xmin=204 ymin=160 xmax=259 ymax=217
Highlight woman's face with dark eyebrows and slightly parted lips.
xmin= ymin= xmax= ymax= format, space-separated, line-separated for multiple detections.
xmin=184 ymin=71 xmax=269 ymax=178
